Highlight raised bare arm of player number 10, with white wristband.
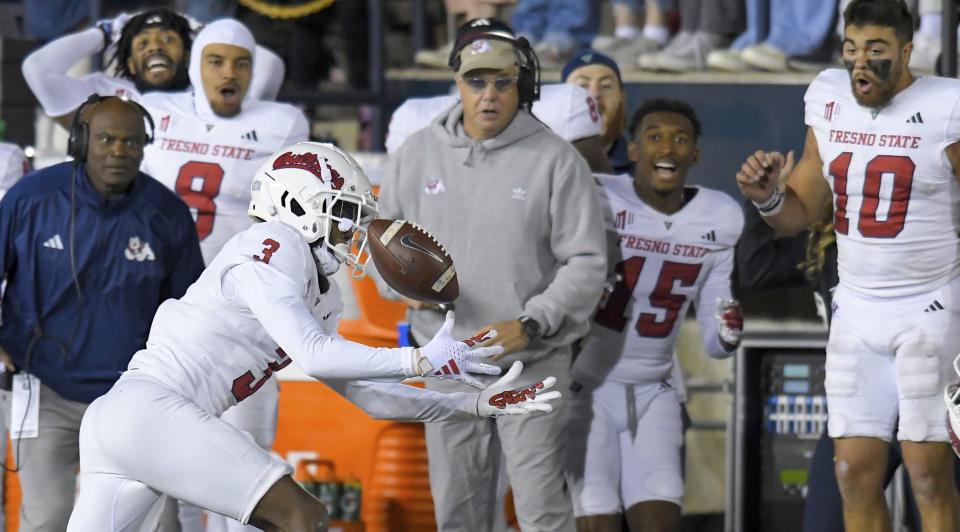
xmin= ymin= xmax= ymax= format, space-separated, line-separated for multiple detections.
xmin=736 ymin=128 xmax=831 ymax=236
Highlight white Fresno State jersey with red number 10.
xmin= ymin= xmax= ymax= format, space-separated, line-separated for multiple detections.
xmin=804 ymin=69 xmax=960 ymax=297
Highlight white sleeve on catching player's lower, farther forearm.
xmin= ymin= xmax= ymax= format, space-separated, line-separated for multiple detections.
xmin=323 ymin=380 xmax=478 ymax=422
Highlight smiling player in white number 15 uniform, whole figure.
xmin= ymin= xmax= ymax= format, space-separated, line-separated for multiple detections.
xmin=567 ymin=100 xmax=743 ymax=532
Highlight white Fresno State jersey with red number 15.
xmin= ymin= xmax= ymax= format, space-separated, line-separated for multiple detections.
xmin=573 ymin=175 xmax=743 ymax=385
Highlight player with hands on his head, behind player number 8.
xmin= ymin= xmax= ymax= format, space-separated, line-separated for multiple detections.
xmin=22 ymin=8 xmax=285 ymax=128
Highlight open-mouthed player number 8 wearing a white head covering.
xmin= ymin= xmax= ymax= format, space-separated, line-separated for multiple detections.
xmin=135 ymin=19 xmax=308 ymax=521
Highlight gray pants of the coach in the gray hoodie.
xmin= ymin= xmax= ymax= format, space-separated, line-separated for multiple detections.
xmin=426 ymin=349 xmax=575 ymax=532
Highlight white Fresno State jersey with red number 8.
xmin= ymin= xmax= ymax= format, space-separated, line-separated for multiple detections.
xmin=141 ymin=91 xmax=308 ymax=264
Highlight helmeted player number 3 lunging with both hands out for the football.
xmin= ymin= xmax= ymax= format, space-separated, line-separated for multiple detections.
xmin=68 ymin=143 xmax=559 ymax=532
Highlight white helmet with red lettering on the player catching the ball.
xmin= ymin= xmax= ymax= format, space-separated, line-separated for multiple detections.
xmin=247 ymin=142 xmax=377 ymax=278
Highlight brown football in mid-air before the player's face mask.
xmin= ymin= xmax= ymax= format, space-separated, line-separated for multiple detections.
xmin=367 ymin=218 xmax=460 ymax=303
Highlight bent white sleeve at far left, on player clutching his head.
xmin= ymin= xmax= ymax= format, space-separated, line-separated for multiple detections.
xmin=22 ymin=28 xmax=103 ymax=117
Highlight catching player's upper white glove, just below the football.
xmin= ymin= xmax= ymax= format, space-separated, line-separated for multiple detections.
xmin=415 ymin=310 xmax=503 ymax=388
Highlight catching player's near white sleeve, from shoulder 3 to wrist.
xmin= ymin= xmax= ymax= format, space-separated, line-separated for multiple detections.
xmin=221 ymin=262 xmax=416 ymax=380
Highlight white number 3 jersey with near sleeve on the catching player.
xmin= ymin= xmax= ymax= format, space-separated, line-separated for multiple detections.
xmin=129 ymin=222 xmax=415 ymax=415
